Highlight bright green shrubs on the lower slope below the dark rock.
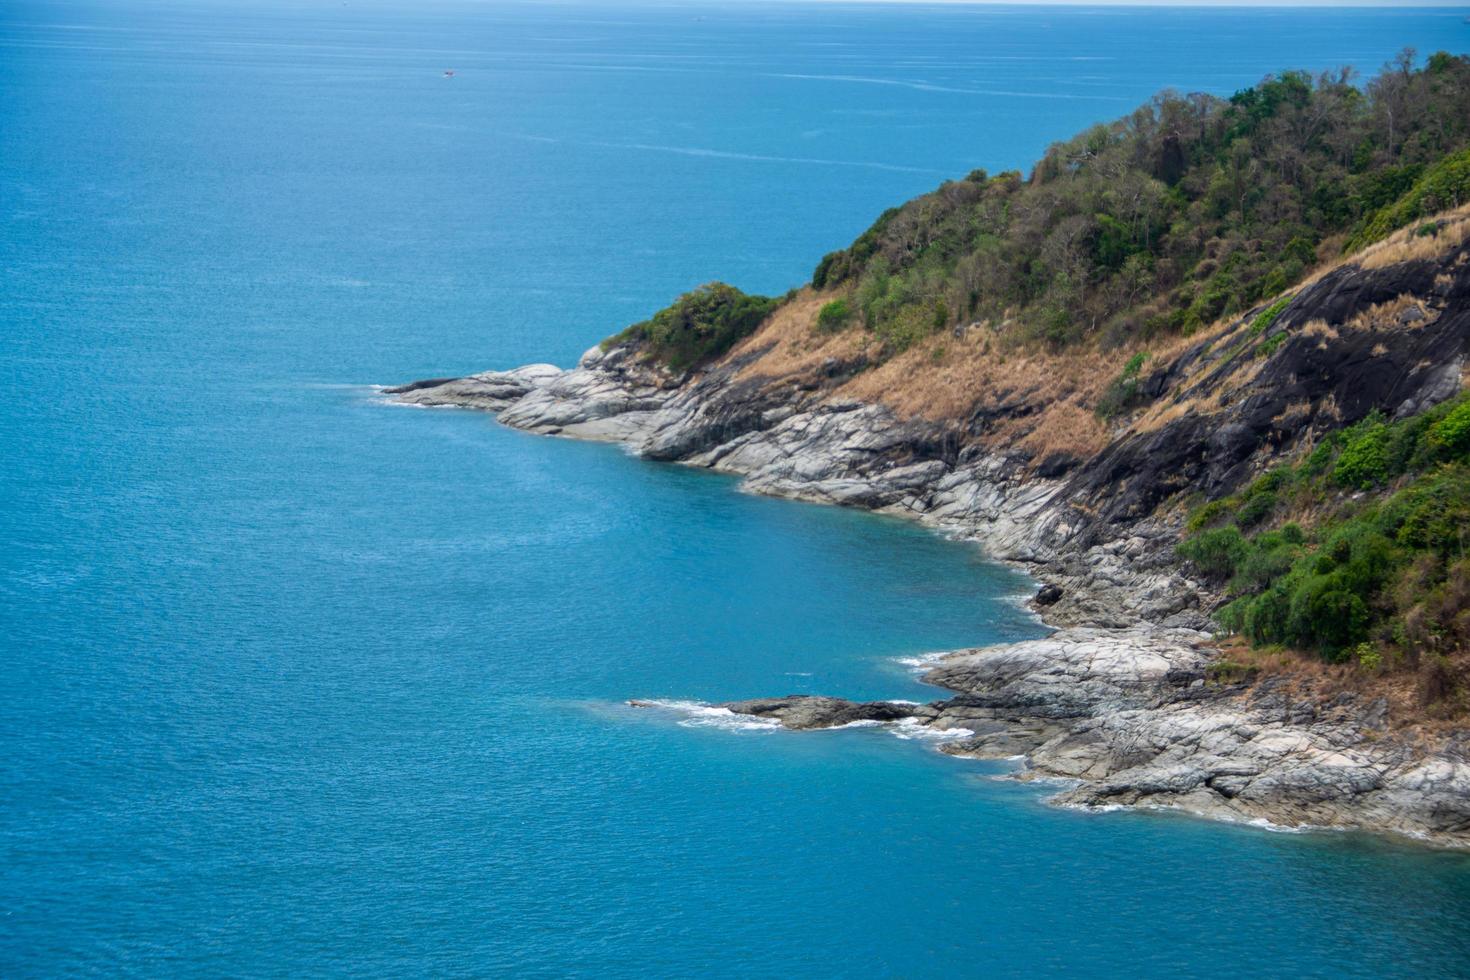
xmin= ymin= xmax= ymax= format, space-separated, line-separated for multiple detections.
xmin=1179 ymin=395 xmax=1470 ymax=705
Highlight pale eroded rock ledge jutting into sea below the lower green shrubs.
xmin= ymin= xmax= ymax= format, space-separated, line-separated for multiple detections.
xmin=720 ymin=627 xmax=1470 ymax=845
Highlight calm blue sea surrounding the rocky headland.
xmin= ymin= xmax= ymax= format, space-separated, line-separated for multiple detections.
xmin=0 ymin=0 xmax=1470 ymax=977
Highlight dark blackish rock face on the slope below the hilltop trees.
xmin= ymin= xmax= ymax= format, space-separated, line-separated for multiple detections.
xmin=1061 ymin=245 xmax=1470 ymax=525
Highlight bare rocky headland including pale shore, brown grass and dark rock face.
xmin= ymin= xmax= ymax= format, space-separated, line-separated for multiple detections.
xmin=387 ymin=213 xmax=1470 ymax=846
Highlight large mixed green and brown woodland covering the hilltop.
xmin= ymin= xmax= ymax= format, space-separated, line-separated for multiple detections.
xmin=813 ymin=53 xmax=1470 ymax=350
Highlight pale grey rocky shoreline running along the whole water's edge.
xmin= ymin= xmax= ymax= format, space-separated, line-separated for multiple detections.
xmin=387 ymin=348 xmax=1470 ymax=846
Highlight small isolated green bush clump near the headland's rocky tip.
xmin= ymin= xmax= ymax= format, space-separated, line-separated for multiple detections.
xmin=603 ymin=282 xmax=781 ymax=372
